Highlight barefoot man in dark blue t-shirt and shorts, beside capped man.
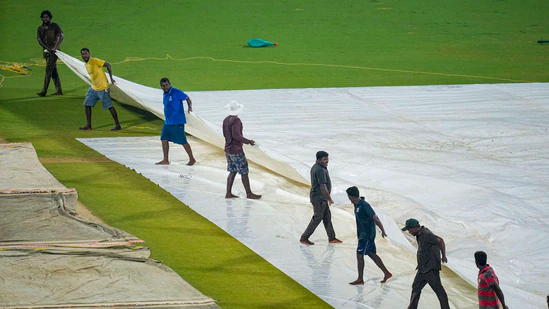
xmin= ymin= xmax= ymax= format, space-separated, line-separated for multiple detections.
xmin=347 ymin=187 xmax=393 ymax=285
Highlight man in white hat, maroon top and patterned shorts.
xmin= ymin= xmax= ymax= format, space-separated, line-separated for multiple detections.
xmin=223 ymin=100 xmax=261 ymax=200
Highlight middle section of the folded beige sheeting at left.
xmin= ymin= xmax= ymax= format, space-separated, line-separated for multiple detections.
xmin=0 ymin=190 xmax=135 ymax=248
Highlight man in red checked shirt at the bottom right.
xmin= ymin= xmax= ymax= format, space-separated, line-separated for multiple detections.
xmin=475 ymin=251 xmax=509 ymax=309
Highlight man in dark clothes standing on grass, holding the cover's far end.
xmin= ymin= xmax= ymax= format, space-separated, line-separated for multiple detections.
xmin=36 ymin=11 xmax=63 ymax=97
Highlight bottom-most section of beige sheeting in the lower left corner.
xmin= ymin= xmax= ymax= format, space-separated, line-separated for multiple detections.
xmin=0 ymin=248 xmax=219 ymax=309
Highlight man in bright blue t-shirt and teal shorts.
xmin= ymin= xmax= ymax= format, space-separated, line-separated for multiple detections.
xmin=156 ymin=77 xmax=196 ymax=165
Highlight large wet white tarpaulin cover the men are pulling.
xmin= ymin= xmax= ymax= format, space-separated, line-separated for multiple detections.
xmin=56 ymin=50 xmax=549 ymax=309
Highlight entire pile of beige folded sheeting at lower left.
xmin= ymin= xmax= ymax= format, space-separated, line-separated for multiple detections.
xmin=0 ymin=143 xmax=219 ymax=309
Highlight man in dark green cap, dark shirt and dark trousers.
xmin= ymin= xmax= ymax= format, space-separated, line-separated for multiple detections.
xmin=402 ymin=219 xmax=450 ymax=309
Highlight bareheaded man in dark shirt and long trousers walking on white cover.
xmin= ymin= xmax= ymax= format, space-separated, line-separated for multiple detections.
xmin=299 ymin=151 xmax=342 ymax=246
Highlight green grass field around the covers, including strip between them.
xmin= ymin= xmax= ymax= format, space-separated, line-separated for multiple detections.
xmin=0 ymin=0 xmax=549 ymax=309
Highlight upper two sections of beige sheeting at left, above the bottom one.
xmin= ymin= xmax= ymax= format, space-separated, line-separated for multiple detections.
xmin=0 ymin=143 xmax=137 ymax=248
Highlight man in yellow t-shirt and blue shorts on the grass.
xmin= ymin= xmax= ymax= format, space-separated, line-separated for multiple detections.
xmin=80 ymin=48 xmax=122 ymax=131
